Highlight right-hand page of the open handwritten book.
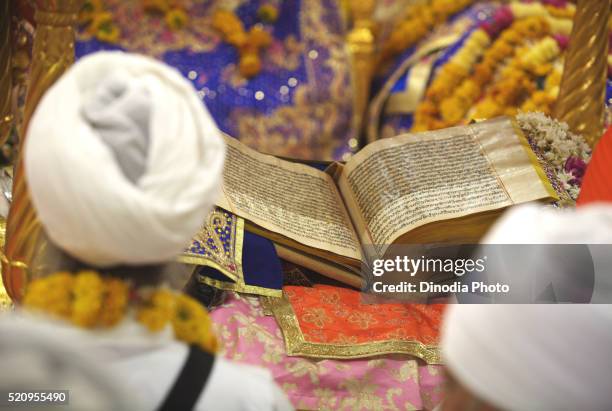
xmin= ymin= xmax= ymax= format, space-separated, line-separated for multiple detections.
xmin=339 ymin=117 xmax=552 ymax=252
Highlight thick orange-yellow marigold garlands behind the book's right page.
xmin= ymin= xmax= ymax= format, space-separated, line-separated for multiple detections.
xmin=412 ymin=2 xmax=573 ymax=131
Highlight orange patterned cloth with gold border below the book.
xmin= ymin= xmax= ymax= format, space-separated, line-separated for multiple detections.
xmin=265 ymin=284 xmax=445 ymax=364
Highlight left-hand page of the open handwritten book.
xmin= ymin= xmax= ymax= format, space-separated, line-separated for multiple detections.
xmin=217 ymin=137 xmax=361 ymax=259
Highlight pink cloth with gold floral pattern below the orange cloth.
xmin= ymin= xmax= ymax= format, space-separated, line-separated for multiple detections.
xmin=211 ymin=293 xmax=444 ymax=411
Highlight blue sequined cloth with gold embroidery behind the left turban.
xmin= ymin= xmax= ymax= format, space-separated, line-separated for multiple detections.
xmin=76 ymin=0 xmax=355 ymax=159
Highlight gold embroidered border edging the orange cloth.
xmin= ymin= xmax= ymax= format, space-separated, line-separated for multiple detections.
xmin=261 ymin=297 xmax=442 ymax=364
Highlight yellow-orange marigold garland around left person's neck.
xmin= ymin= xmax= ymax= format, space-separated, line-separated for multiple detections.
xmin=23 ymin=271 xmax=219 ymax=353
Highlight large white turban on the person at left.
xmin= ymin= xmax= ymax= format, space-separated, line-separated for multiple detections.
xmin=25 ymin=52 xmax=225 ymax=267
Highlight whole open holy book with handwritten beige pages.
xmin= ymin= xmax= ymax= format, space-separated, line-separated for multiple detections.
xmin=217 ymin=117 xmax=556 ymax=287
